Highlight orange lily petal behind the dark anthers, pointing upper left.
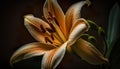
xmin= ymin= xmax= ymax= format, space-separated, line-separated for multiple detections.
xmin=25 ymin=15 xmax=59 ymax=44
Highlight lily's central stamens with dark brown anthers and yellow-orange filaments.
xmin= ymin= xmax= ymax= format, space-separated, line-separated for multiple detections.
xmin=40 ymin=12 xmax=66 ymax=44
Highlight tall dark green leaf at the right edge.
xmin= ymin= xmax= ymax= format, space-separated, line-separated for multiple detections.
xmin=106 ymin=3 xmax=120 ymax=57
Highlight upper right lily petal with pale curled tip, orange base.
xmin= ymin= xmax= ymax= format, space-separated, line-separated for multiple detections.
xmin=65 ymin=1 xmax=88 ymax=35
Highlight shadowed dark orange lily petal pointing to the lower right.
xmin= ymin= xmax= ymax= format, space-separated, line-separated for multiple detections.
xmin=72 ymin=39 xmax=108 ymax=65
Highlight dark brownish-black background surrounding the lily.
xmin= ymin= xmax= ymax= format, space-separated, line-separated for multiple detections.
xmin=0 ymin=0 xmax=120 ymax=69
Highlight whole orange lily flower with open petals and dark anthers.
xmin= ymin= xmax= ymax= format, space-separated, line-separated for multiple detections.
xmin=10 ymin=0 xmax=108 ymax=69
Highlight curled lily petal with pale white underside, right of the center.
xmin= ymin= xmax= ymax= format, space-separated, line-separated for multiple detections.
xmin=68 ymin=18 xmax=89 ymax=44
